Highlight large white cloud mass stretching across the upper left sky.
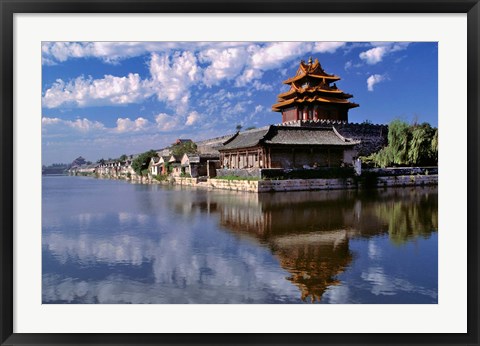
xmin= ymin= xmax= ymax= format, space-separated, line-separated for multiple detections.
xmin=42 ymin=42 xmax=352 ymax=112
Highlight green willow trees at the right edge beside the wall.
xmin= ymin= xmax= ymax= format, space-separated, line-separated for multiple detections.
xmin=362 ymin=120 xmax=438 ymax=167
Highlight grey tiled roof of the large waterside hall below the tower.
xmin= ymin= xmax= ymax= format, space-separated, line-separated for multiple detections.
xmin=220 ymin=125 xmax=360 ymax=150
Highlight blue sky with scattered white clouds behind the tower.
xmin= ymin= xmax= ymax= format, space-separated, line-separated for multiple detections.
xmin=42 ymin=42 xmax=438 ymax=165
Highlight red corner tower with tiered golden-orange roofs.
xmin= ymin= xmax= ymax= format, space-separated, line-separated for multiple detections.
xmin=272 ymin=58 xmax=359 ymax=123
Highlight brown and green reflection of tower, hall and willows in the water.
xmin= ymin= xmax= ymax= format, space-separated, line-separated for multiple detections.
xmin=177 ymin=187 xmax=438 ymax=302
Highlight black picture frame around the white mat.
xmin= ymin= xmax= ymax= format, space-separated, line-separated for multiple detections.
xmin=0 ymin=0 xmax=480 ymax=345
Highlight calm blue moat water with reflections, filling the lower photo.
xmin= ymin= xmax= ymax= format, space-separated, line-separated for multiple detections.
xmin=42 ymin=176 xmax=438 ymax=304
